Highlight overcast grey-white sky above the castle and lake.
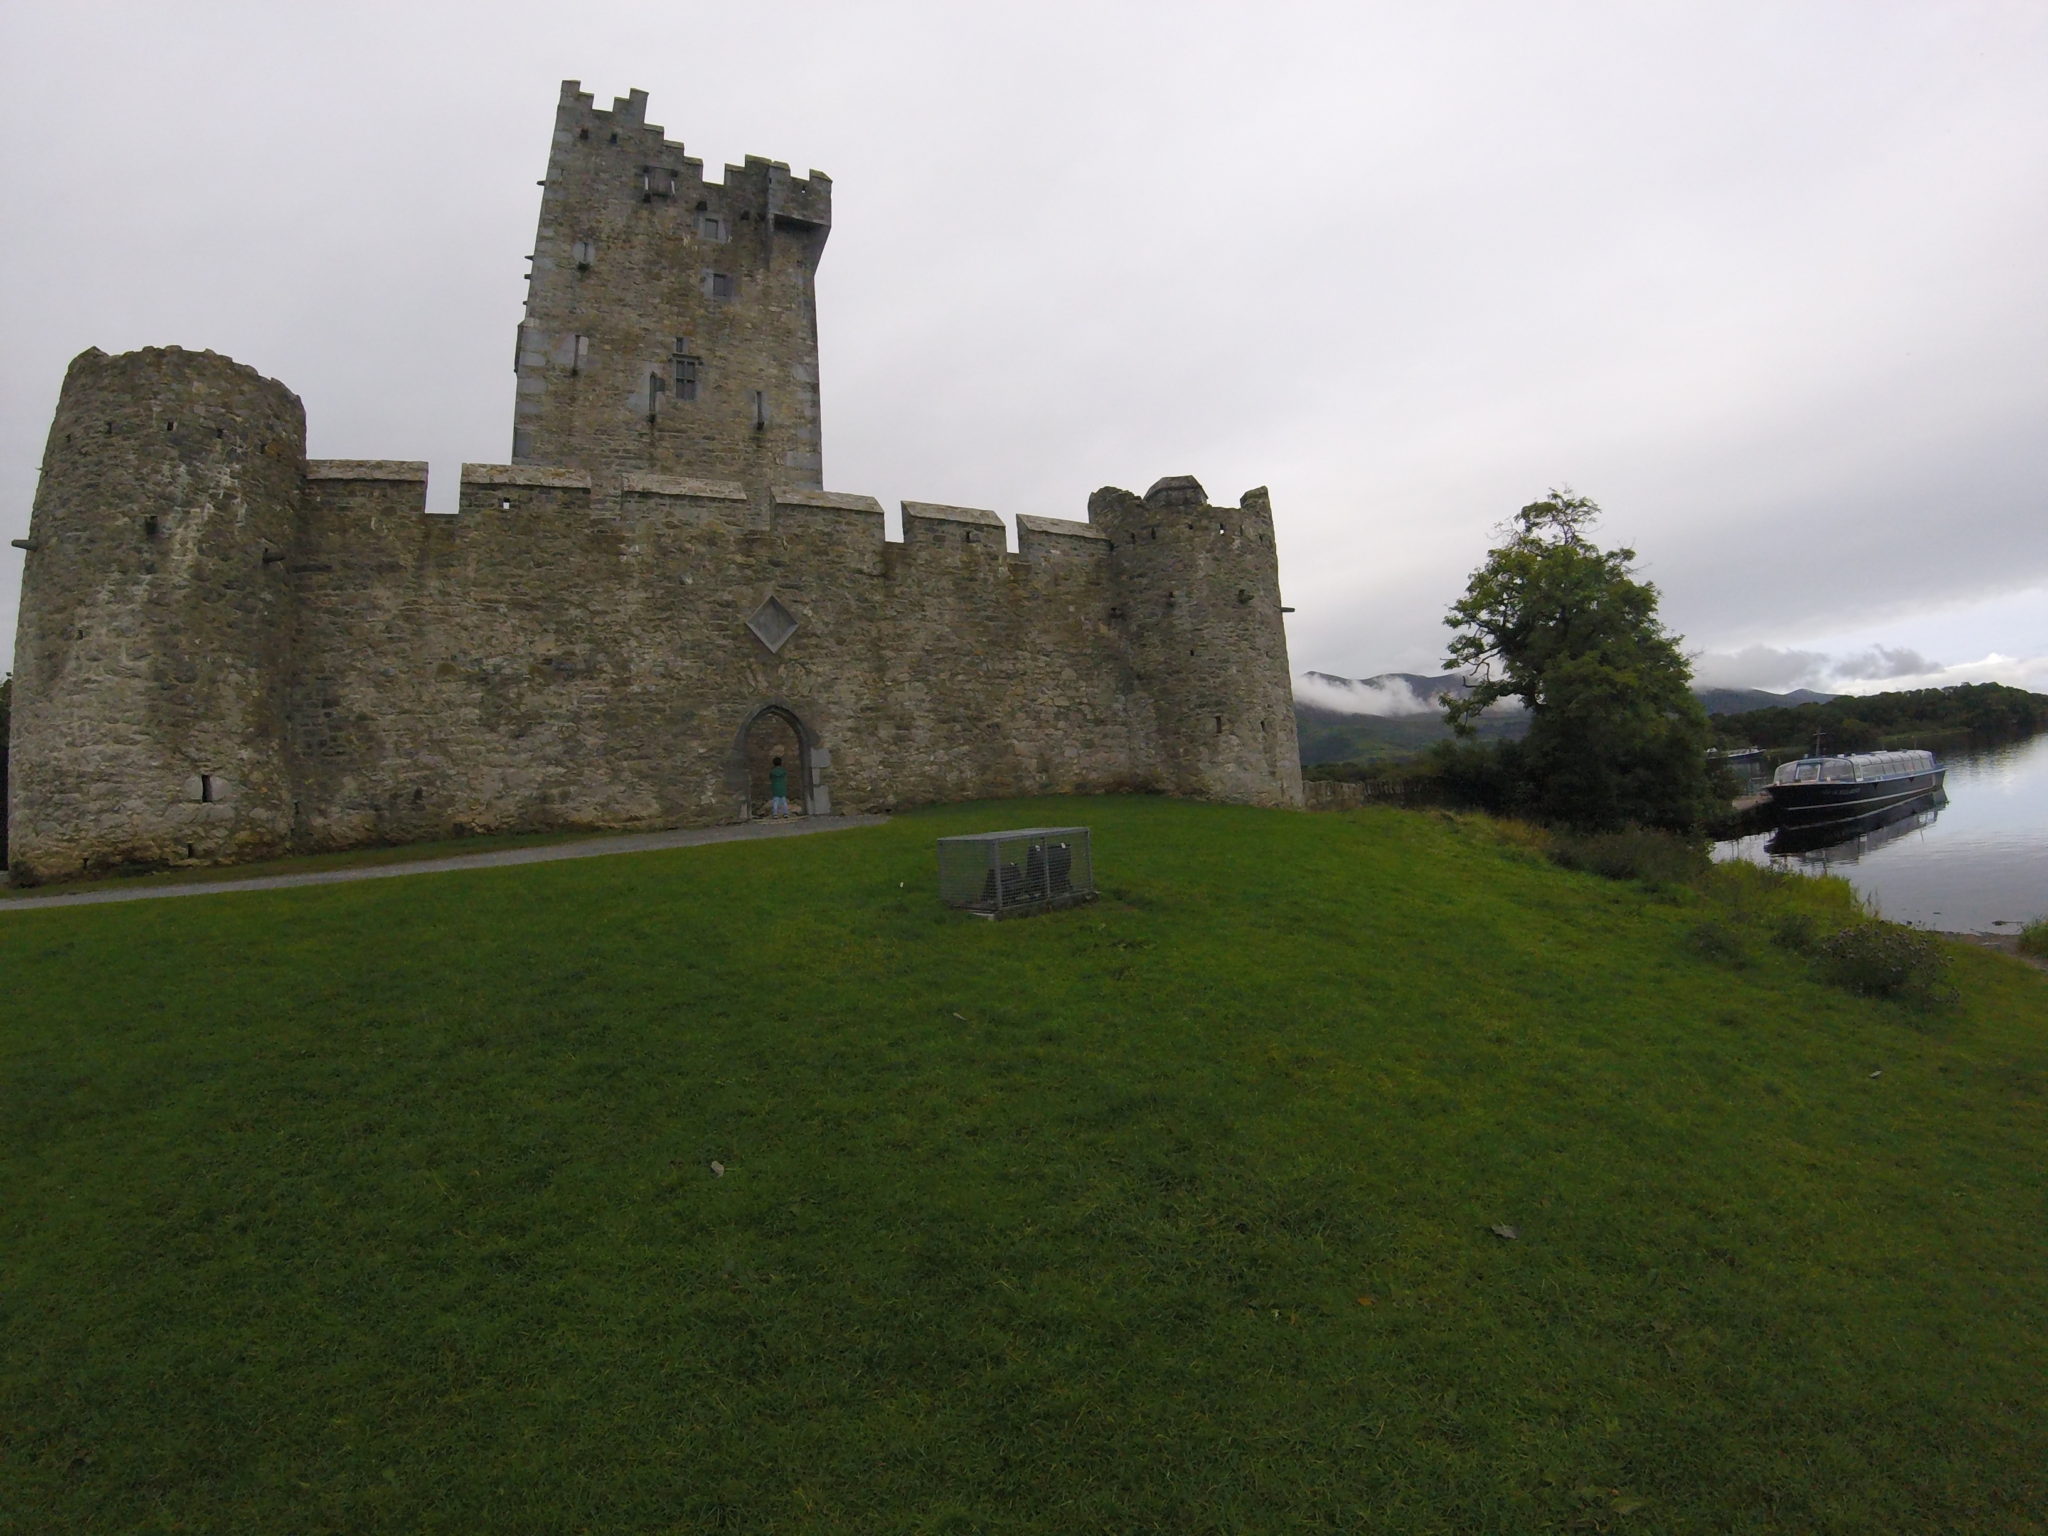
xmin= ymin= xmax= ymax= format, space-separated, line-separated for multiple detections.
xmin=0 ymin=0 xmax=2048 ymax=690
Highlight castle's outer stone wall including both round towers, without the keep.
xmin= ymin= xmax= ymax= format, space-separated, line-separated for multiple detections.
xmin=10 ymin=368 xmax=1300 ymax=879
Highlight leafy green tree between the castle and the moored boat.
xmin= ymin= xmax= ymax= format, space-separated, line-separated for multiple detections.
xmin=1444 ymin=489 xmax=1722 ymax=831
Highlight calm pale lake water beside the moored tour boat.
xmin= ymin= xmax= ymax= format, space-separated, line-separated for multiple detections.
xmin=1714 ymin=735 xmax=2048 ymax=934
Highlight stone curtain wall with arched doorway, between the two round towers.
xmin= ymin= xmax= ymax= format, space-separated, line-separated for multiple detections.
xmin=274 ymin=463 xmax=1157 ymax=846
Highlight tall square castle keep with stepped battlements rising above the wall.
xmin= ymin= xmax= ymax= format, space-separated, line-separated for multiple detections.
xmin=512 ymin=80 xmax=831 ymax=496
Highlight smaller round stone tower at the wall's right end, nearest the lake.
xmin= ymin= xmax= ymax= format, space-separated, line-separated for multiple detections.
xmin=1087 ymin=475 xmax=1300 ymax=805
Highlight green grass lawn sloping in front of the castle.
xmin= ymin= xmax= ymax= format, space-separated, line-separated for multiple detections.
xmin=0 ymin=799 xmax=2048 ymax=1534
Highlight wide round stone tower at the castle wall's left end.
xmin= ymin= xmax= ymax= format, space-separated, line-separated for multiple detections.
xmin=8 ymin=346 xmax=305 ymax=879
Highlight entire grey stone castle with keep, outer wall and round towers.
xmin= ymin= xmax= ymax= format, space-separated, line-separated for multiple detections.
xmin=8 ymin=82 xmax=1300 ymax=881
